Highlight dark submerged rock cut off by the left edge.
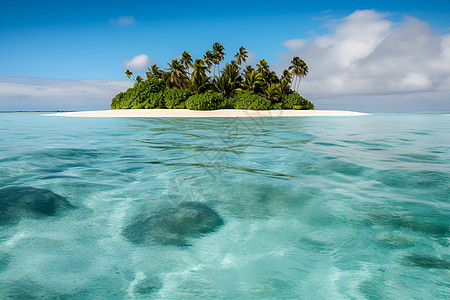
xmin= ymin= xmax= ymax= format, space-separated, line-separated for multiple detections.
xmin=0 ymin=187 xmax=73 ymax=224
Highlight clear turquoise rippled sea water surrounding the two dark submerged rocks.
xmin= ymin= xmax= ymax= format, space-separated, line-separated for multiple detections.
xmin=0 ymin=113 xmax=450 ymax=299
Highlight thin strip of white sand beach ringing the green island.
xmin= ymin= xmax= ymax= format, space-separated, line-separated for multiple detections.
xmin=45 ymin=109 xmax=369 ymax=118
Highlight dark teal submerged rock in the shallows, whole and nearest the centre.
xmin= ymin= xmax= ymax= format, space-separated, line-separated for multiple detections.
xmin=122 ymin=202 xmax=223 ymax=246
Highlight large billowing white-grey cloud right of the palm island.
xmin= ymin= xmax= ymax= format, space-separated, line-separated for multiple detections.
xmin=283 ymin=10 xmax=450 ymax=109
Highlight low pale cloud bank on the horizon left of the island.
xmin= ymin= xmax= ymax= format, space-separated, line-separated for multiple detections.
xmin=0 ymin=77 xmax=132 ymax=110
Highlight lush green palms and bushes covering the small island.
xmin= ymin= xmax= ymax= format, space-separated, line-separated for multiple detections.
xmin=111 ymin=43 xmax=314 ymax=110
